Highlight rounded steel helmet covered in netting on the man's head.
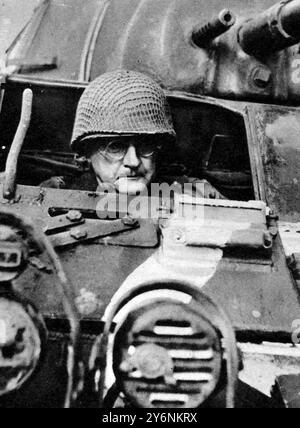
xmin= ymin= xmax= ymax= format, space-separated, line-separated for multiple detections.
xmin=71 ymin=70 xmax=175 ymax=151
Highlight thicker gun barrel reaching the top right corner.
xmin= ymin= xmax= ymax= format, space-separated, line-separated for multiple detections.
xmin=238 ymin=0 xmax=300 ymax=56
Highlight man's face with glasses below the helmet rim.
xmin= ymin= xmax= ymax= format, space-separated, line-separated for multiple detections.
xmin=90 ymin=136 xmax=159 ymax=195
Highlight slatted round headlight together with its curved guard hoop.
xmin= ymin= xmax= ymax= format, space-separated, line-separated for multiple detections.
xmin=95 ymin=281 xmax=238 ymax=408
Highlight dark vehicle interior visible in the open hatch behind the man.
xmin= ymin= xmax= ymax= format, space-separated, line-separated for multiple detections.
xmin=0 ymin=78 xmax=254 ymax=201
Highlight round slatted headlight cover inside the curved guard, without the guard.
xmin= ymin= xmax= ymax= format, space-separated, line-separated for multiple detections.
xmin=113 ymin=301 xmax=222 ymax=408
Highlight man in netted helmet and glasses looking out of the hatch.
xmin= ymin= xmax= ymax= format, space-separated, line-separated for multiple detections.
xmin=44 ymin=70 xmax=222 ymax=198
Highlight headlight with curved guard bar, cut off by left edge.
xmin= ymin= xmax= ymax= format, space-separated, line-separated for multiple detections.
xmin=0 ymin=210 xmax=84 ymax=408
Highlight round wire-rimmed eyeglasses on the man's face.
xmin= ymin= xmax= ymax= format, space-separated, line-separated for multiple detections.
xmin=97 ymin=138 xmax=161 ymax=161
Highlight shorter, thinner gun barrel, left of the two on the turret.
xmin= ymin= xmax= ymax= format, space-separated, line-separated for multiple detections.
xmin=192 ymin=9 xmax=236 ymax=48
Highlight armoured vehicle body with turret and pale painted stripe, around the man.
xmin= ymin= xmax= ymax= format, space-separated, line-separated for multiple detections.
xmin=0 ymin=0 xmax=300 ymax=407
